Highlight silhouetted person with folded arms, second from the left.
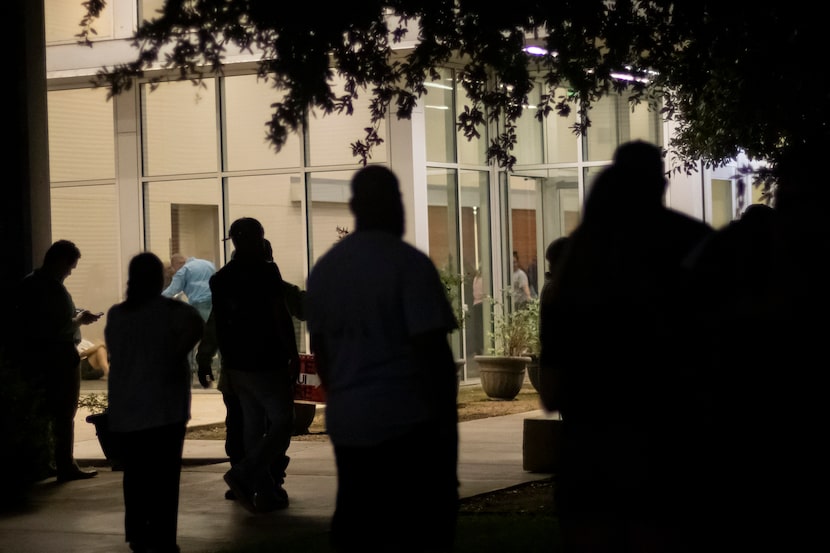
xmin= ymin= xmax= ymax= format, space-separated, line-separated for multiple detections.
xmin=104 ymin=252 xmax=204 ymax=553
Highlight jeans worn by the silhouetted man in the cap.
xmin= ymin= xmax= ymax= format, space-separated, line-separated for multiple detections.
xmin=225 ymin=369 xmax=294 ymax=484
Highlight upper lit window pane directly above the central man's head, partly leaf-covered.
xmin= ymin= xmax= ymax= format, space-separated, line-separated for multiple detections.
xmin=307 ymin=77 xmax=389 ymax=167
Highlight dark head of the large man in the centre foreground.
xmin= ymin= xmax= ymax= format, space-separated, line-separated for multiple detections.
xmin=349 ymin=165 xmax=404 ymax=236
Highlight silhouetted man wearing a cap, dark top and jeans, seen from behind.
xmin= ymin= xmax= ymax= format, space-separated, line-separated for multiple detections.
xmin=210 ymin=217 xmax=300 ymax=513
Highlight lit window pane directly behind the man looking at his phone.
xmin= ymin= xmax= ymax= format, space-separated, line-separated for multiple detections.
xmin=51 ymin=184 xmax=123 ymax=342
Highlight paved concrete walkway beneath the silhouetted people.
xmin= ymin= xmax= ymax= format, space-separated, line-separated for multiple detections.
xmin=0 ymin=390 xmax=560 ymax=553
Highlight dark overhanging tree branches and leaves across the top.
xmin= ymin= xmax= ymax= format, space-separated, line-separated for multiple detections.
xmin=78 ymin=0 xmax=830 ymax=198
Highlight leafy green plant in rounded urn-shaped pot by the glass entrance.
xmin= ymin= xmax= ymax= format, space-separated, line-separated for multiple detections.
xmin=475 ymin=290 xmax=539 ymax=400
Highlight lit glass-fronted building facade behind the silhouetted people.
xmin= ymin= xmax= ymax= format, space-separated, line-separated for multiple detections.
xmin=45 ymin=0 xmax=751 ymax=380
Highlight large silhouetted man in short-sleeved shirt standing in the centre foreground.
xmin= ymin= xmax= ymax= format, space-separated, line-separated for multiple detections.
xmin=306 ymin=166 xmax=458 ymax=553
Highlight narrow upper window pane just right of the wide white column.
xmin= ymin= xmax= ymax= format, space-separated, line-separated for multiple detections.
xmin=421 ymin=69 xmax=458 ymax=163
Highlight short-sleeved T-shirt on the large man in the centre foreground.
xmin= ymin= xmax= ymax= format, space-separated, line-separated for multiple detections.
xmin=306 ymin=231 xmax=456 ymax=446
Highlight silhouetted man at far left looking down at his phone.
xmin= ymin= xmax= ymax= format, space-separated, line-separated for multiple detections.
xmin=13 ymin=240 xmax=100 ymax=482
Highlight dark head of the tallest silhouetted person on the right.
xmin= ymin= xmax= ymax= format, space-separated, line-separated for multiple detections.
xmin=613 ymin=140 xmax=667 ymax=203
